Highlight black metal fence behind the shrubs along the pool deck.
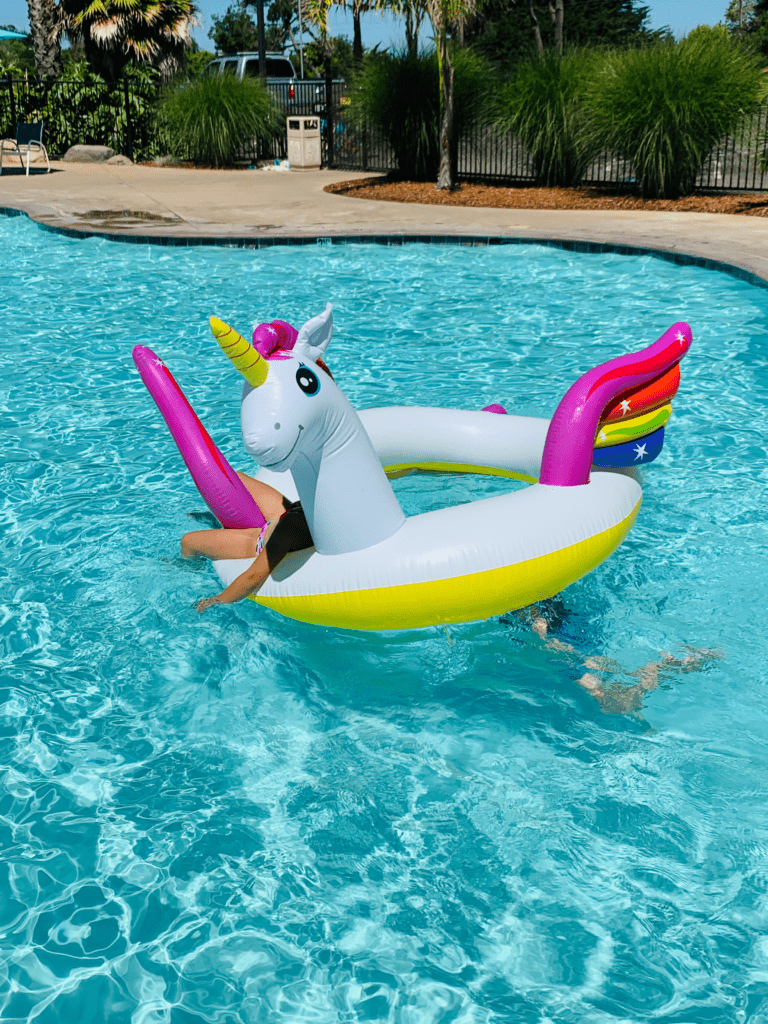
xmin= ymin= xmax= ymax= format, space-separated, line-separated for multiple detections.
xmin=0 ymin=78 xmax=768 ymax=191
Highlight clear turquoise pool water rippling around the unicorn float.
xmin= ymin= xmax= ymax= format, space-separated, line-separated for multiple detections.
xmin=0 ymin=211 xmax=768 ymax=1024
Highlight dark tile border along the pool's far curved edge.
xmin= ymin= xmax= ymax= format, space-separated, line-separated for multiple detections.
xmin=0 ymin=206 xmax=768 ymax=289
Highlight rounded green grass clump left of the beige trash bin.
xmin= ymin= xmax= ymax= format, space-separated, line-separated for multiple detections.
xmin=158 ymin=75 xmax=282 ymax=167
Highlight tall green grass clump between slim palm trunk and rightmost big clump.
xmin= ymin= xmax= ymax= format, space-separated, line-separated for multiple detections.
xmin=490 ymin=49 xmax=600 ymax=186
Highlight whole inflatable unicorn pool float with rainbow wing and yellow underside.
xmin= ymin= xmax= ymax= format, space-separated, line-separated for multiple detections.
xmin=133 ymin=305 xmax=691 ymax=630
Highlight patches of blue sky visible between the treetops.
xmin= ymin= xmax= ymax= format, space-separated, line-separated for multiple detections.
xmin=0 ymin=0 xmax=741 ymax=55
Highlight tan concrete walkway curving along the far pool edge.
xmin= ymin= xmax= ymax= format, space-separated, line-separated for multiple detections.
xmin=0 ymin=158 xmax=768 ymax=281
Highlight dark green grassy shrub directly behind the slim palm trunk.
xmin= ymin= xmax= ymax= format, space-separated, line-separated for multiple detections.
xmin=349 ymin=50 xmax=486 ymax=181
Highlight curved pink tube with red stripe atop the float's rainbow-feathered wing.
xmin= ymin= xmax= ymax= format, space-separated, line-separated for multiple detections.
xmin=540 ymin=323 xmax=692 ymax=487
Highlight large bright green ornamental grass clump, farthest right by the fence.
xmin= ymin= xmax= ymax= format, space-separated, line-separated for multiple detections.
xmin=588 ymin=26 xmax=765 ymax=199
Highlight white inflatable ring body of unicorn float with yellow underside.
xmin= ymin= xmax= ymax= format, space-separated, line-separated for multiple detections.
xmin=214 ymin=408 xmax=642 ymax=630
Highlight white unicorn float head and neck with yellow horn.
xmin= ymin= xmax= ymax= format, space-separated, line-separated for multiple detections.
xmin=211 ymin=303 xmax=406 ymax=555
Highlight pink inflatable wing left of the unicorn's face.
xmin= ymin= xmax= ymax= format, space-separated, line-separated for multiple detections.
xmin=133 ymin=345 xmax=264 ymax=529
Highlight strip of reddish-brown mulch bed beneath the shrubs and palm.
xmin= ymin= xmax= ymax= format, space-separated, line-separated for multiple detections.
xmin=326 ymin=177 xmax=768 ymax=217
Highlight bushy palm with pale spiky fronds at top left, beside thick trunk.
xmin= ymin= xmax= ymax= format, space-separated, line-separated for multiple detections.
xmin=58 ymin=0 xmax=197 ymax=81
